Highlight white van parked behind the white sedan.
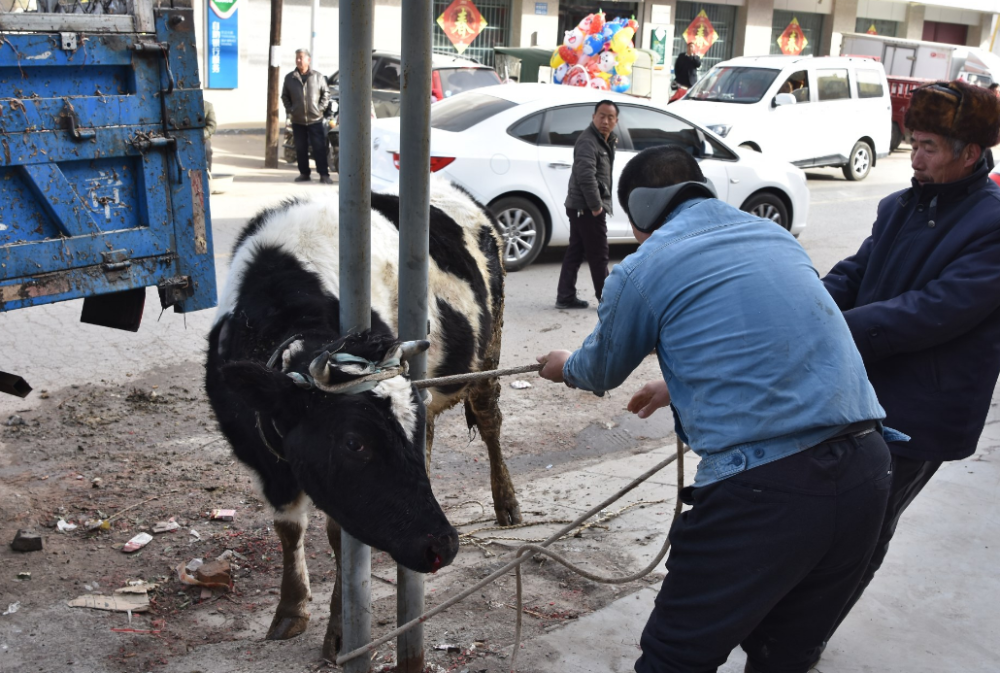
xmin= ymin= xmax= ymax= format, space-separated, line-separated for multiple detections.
xmin=670 ymin=56 xmax=892 ymax=180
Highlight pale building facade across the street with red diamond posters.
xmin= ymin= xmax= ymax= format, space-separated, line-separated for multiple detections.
xmin=194 ymin=0 xmax=1000 ymax=128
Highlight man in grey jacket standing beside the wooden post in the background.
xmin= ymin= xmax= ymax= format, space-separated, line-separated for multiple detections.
xmin=281 ymin=49 xmax=333 ymax=185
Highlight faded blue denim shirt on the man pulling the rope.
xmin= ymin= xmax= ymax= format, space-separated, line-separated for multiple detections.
xmin=563 ymin=198 xmax=885 ymax=486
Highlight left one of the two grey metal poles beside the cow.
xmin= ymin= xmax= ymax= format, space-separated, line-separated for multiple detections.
xmin=340 ymin=0 xmax=374 ymax=673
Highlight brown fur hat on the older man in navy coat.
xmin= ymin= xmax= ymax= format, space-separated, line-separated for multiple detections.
xmin=904 ymin=80 xmax=1000 ymax=147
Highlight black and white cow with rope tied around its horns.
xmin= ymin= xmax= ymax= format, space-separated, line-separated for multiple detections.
xmin=200 ymin=182 xmax=520 ymax=658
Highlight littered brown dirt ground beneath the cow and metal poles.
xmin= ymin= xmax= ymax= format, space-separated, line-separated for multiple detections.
xmin=0 ymin=350 xmax=670 ymax=673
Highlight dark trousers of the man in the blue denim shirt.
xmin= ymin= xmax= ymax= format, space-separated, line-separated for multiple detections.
xmin=635 ymin=432 xmax=892 ymax=673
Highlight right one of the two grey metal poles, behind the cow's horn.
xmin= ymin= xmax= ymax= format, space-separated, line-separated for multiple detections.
xmin=396 ymin=0 xmax=433 ymax=673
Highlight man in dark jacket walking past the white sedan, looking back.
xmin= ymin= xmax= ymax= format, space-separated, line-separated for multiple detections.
xmin=556 ymin=100 xmax=618 ymax=308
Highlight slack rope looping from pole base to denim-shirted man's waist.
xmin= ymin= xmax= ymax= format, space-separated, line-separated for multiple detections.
xmin=336 ymin=440 xmax=689 ymax=673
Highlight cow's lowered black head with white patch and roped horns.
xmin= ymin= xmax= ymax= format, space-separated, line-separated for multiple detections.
xmin=222 ymin=332 xmax=458 ymax=572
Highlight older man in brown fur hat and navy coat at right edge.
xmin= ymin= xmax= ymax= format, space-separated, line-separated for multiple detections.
xmin=823 ymin=81 xmax=1000 ymax=635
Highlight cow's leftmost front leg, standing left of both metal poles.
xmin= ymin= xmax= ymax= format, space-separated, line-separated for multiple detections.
xmin=267 ymin=494 xmax=312 ymax=640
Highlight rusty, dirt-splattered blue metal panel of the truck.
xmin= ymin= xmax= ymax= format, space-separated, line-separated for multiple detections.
xmin=0 ymin=4 xmax=216 ymax=311
